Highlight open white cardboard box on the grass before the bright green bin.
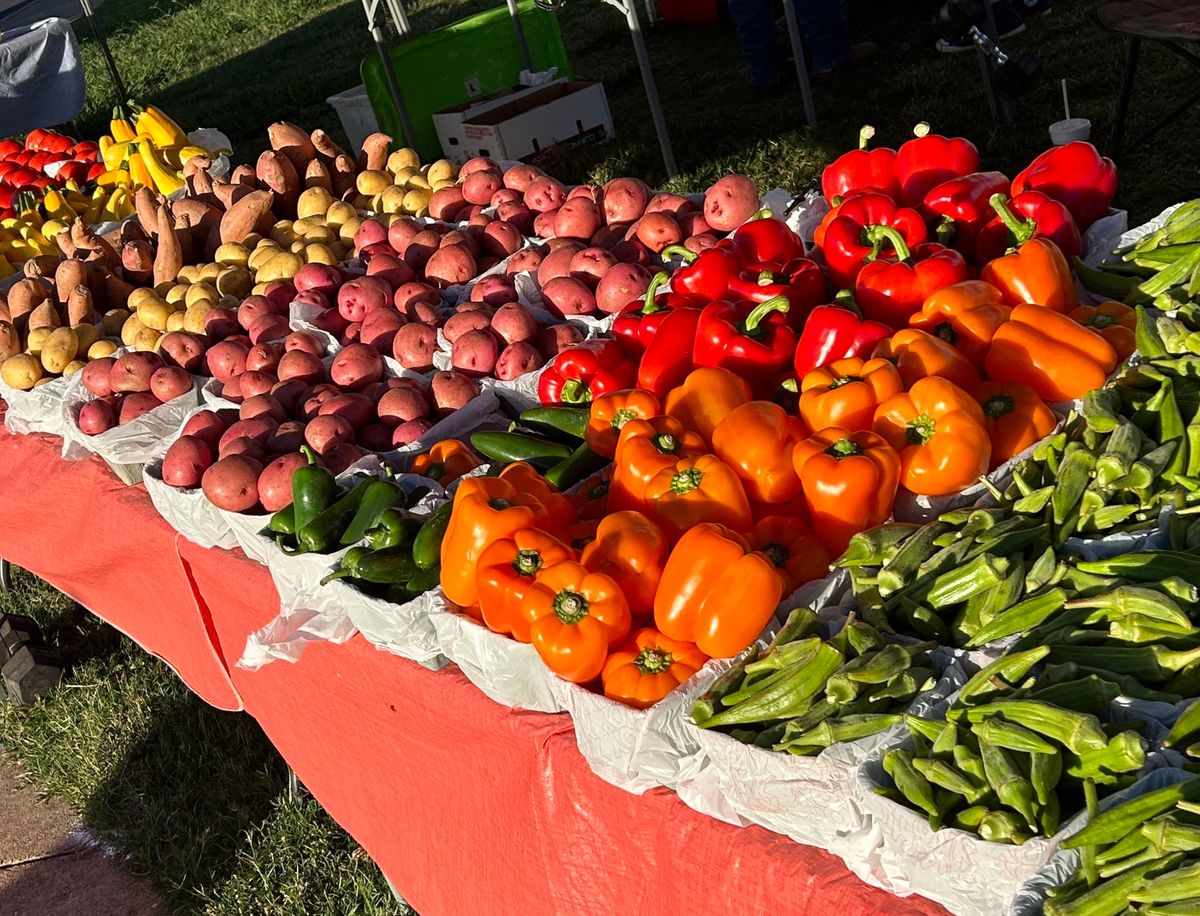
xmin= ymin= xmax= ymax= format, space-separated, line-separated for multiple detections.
xmin=433 ymin=79 xmax=613 ymax=163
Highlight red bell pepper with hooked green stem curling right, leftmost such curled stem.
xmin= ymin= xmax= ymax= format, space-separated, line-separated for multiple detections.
xmin=692 ymin=297 xmax=796 ymax=393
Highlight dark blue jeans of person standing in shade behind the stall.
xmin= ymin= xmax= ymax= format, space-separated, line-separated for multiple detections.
xmin=728 ymin=0 xmax=850 ymax=85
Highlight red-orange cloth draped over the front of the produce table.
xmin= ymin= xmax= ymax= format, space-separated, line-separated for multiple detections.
xmin=0 ymin=412 xmax=944 ymax=916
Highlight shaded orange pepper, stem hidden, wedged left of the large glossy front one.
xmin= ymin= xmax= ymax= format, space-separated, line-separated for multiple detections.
xmin=580 ymin=511 xmax=671 ymax=621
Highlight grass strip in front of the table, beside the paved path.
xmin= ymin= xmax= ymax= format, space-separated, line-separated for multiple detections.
xmin=0 ymin=571 xmax=404 ymax=916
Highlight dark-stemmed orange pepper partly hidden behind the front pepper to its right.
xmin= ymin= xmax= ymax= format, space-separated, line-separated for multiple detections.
xmin=475 ymin=528 xmax=575 ymax=642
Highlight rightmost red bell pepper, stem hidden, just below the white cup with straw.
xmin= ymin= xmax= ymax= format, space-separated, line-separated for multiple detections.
xmin=1013 ymin=140 xmax=1117 ymax=232
